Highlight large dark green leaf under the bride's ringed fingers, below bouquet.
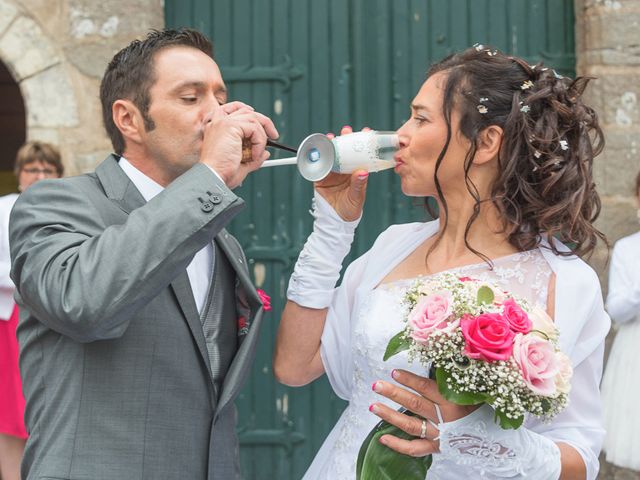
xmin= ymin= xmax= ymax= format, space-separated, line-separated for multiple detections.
xmin=356 ymin=411 xmax=432 ymax=480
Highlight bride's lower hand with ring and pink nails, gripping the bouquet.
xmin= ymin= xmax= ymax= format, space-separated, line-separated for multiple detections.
xmin=370 ymin=370 xmax=478 ymax=457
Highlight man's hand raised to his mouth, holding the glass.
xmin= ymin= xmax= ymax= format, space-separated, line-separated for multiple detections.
xmin=200 ymin=102 xmax=278 ymax=188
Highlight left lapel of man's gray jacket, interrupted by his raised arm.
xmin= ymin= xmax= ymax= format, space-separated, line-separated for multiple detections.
xmin=96 ymin=155 xmax=211 ymax=378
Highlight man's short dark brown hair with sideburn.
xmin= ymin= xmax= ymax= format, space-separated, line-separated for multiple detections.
xmin=100 ymin=28 xmax=213 ymax=155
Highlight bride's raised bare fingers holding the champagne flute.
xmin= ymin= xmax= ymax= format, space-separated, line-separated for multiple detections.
xmin=314 ymin=127 xmax=369 ymax=222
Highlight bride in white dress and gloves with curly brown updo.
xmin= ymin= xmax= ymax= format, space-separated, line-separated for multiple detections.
xmin=274 ymin=46 xmax=609 ymax=480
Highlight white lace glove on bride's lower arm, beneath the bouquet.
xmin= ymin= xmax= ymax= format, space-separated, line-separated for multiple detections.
xmin=427 ymin=404 xmax=561 ymax=480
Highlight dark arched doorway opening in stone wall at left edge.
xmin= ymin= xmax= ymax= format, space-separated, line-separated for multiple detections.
xmin=0 ymin=62 xmax=26 ymax=195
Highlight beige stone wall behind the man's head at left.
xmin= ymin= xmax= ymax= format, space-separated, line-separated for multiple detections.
xmin=0 ymin=0 xmax=164 ymax=175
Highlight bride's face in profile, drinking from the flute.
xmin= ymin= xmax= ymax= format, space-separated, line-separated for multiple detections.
xmin=395 ymin=72 xmax=470 ymax=197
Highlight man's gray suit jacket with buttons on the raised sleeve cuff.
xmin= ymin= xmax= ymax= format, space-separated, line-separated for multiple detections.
xmin=10 ymin=156 xmax=263 ymax=480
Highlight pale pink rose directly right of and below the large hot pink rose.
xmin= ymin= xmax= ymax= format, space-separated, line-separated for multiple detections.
xmin=513 ymin=333 xmax=560 ymax=397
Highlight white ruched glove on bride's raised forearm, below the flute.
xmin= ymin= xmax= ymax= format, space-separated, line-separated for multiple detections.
xmin=287 ymin=193 xmax=360 ymax=308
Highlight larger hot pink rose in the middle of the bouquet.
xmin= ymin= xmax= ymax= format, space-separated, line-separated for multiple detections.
xmin=460 ymin=313 xmax=515 ymax=362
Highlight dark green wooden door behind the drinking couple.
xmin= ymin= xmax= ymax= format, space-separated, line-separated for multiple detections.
xmin=165 ymin=0 xmax=575 ymax=480
